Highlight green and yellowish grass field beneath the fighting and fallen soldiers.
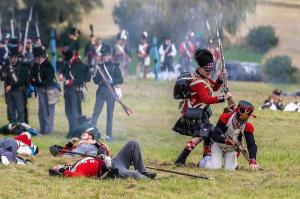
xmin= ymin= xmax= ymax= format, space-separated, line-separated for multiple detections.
xmin=0 ymin=77 xmax=300 ymax=199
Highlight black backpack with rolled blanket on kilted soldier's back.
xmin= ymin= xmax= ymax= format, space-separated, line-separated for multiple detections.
xmin=173 ymin=72 xmax=192 ymax=99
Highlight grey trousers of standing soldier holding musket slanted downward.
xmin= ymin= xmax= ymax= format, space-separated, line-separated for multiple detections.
xmin=92 ymin=86 xmax=115 ymax=137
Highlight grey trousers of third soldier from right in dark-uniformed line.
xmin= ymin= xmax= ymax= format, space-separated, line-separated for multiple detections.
xmin=37 ymin=88 xmax=55 ymax=134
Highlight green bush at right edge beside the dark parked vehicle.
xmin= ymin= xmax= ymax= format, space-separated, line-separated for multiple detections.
xmin=263 ymin=55 xmax=299 ymax=83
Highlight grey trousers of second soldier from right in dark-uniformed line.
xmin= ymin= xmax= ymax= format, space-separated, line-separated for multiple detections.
xmin=64 ymin=86 xmax=83 ymax=132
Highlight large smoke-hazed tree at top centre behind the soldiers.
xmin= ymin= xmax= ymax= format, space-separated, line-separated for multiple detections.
xmin=113 ymin=0 xmax=256 ymax=45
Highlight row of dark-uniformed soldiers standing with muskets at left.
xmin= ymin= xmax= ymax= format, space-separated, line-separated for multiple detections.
xmin=0 ymin=28 xmax=123 ymax=139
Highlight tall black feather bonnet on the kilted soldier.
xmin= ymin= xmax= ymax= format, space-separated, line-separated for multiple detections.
xmin=195 ymin=49 xmax=214 ymax=71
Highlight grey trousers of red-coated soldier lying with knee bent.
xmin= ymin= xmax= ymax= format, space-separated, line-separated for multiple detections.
xmin=112 ymin=141 xmax=145 ymax=179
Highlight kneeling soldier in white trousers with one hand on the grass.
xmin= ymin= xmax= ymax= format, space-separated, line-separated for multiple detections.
xmin=199 ymin=100 xmax=259 ymax=170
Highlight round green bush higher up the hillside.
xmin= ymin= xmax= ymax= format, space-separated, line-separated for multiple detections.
xmin=246 ymin=26 xmax=278 ymax=53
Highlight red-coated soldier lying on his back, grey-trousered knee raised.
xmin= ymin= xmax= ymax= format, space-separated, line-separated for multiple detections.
xmin=49 ymin=141 xmax=156 ymax=179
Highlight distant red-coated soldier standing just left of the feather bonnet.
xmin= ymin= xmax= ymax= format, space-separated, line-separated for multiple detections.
xmin=179 ymin=32 xmax=195 ymax=72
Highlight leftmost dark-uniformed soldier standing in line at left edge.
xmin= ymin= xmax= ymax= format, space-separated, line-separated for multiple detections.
xmin=4 ymin=39 xmax=29 ymax=123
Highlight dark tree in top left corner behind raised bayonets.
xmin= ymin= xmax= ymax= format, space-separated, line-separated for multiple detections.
xmin=0 ymin=0 xmax=103 ymax=44
